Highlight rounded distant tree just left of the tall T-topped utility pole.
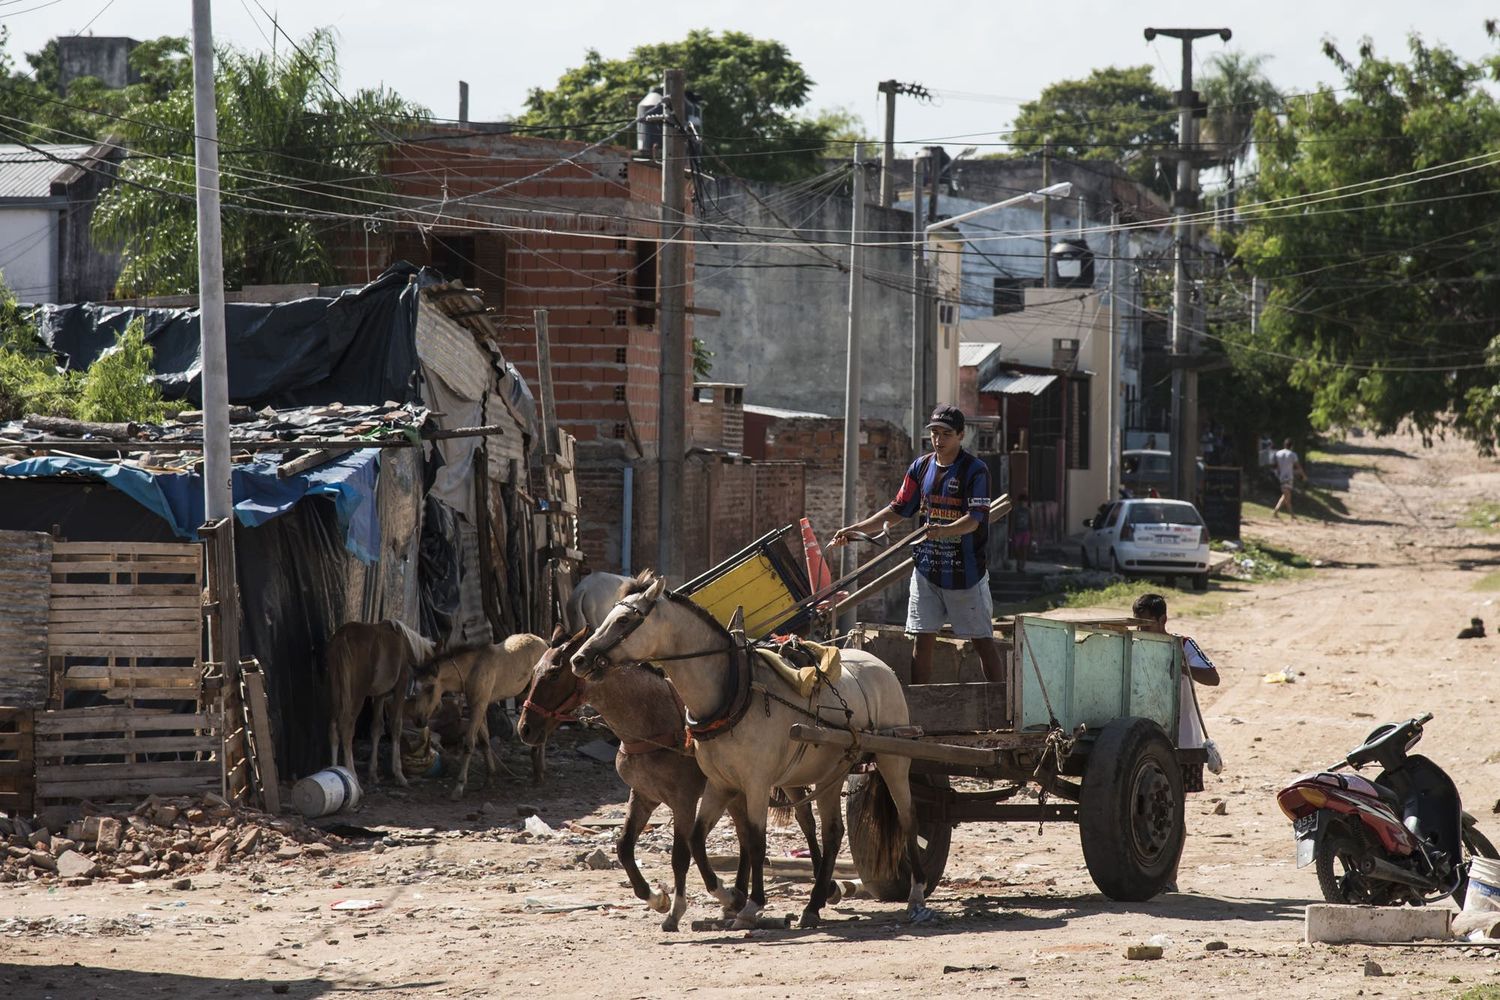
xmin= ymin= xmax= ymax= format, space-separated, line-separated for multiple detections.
xmin=1008 ymin=66 xmax=1178 ymax=195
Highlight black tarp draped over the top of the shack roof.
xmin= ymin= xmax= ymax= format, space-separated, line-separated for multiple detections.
xmin=38 ymin=261 xmax=441 ymax=408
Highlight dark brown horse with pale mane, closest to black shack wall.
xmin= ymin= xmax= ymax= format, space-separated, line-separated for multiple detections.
xmin=324 ymin=619 xmax=437 ymax=786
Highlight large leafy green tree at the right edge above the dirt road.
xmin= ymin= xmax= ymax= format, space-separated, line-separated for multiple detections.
xmin=1238 ymin=27 xmax=1500 ymax=448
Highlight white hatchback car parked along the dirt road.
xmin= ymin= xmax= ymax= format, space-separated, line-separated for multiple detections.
xmin=1083 ymin=499 xmax=1209 ymax=591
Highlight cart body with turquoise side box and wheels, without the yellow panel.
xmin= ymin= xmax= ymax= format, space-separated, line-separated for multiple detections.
xmin=816 ymin=615 xmax=1203 ymax=901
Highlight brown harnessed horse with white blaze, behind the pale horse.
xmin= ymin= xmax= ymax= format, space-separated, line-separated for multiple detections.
xmin=516 ymin=628 xmax=819 ymax=931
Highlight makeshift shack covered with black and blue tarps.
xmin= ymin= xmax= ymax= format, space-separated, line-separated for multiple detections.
xmin=0 ymin=265 xmax=546 ymax=777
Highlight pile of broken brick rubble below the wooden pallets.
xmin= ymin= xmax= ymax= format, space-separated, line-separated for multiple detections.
xmin=0 ymin=795 xmax=338 ymax=888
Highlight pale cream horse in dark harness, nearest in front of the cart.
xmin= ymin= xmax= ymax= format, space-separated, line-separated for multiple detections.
xmin=573 ymin=571 xmax=927 ymax=930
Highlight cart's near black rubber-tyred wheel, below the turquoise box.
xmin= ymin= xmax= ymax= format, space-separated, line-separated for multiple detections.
xmin=1079 ymin=717 xmax=1187 ymax=903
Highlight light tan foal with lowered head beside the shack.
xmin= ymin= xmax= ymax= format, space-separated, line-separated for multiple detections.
xmin=413 ymin=633 xmax=548 ymax=799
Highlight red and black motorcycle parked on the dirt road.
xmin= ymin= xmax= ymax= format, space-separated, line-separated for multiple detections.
xmin=1277 ymin=712 xmax=1500 ymax=906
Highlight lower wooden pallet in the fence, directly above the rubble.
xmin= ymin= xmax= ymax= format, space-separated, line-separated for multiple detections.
xmin=35 ymin=706 xmax=221 ymax=802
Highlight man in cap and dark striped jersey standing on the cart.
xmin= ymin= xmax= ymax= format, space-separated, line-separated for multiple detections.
xmin=831 ymin=405 xmax=1004 ymax=684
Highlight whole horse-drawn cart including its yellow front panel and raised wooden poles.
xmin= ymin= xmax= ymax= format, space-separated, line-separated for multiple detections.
xmin=663 ymin=496 xmax=1205 ymax=901
